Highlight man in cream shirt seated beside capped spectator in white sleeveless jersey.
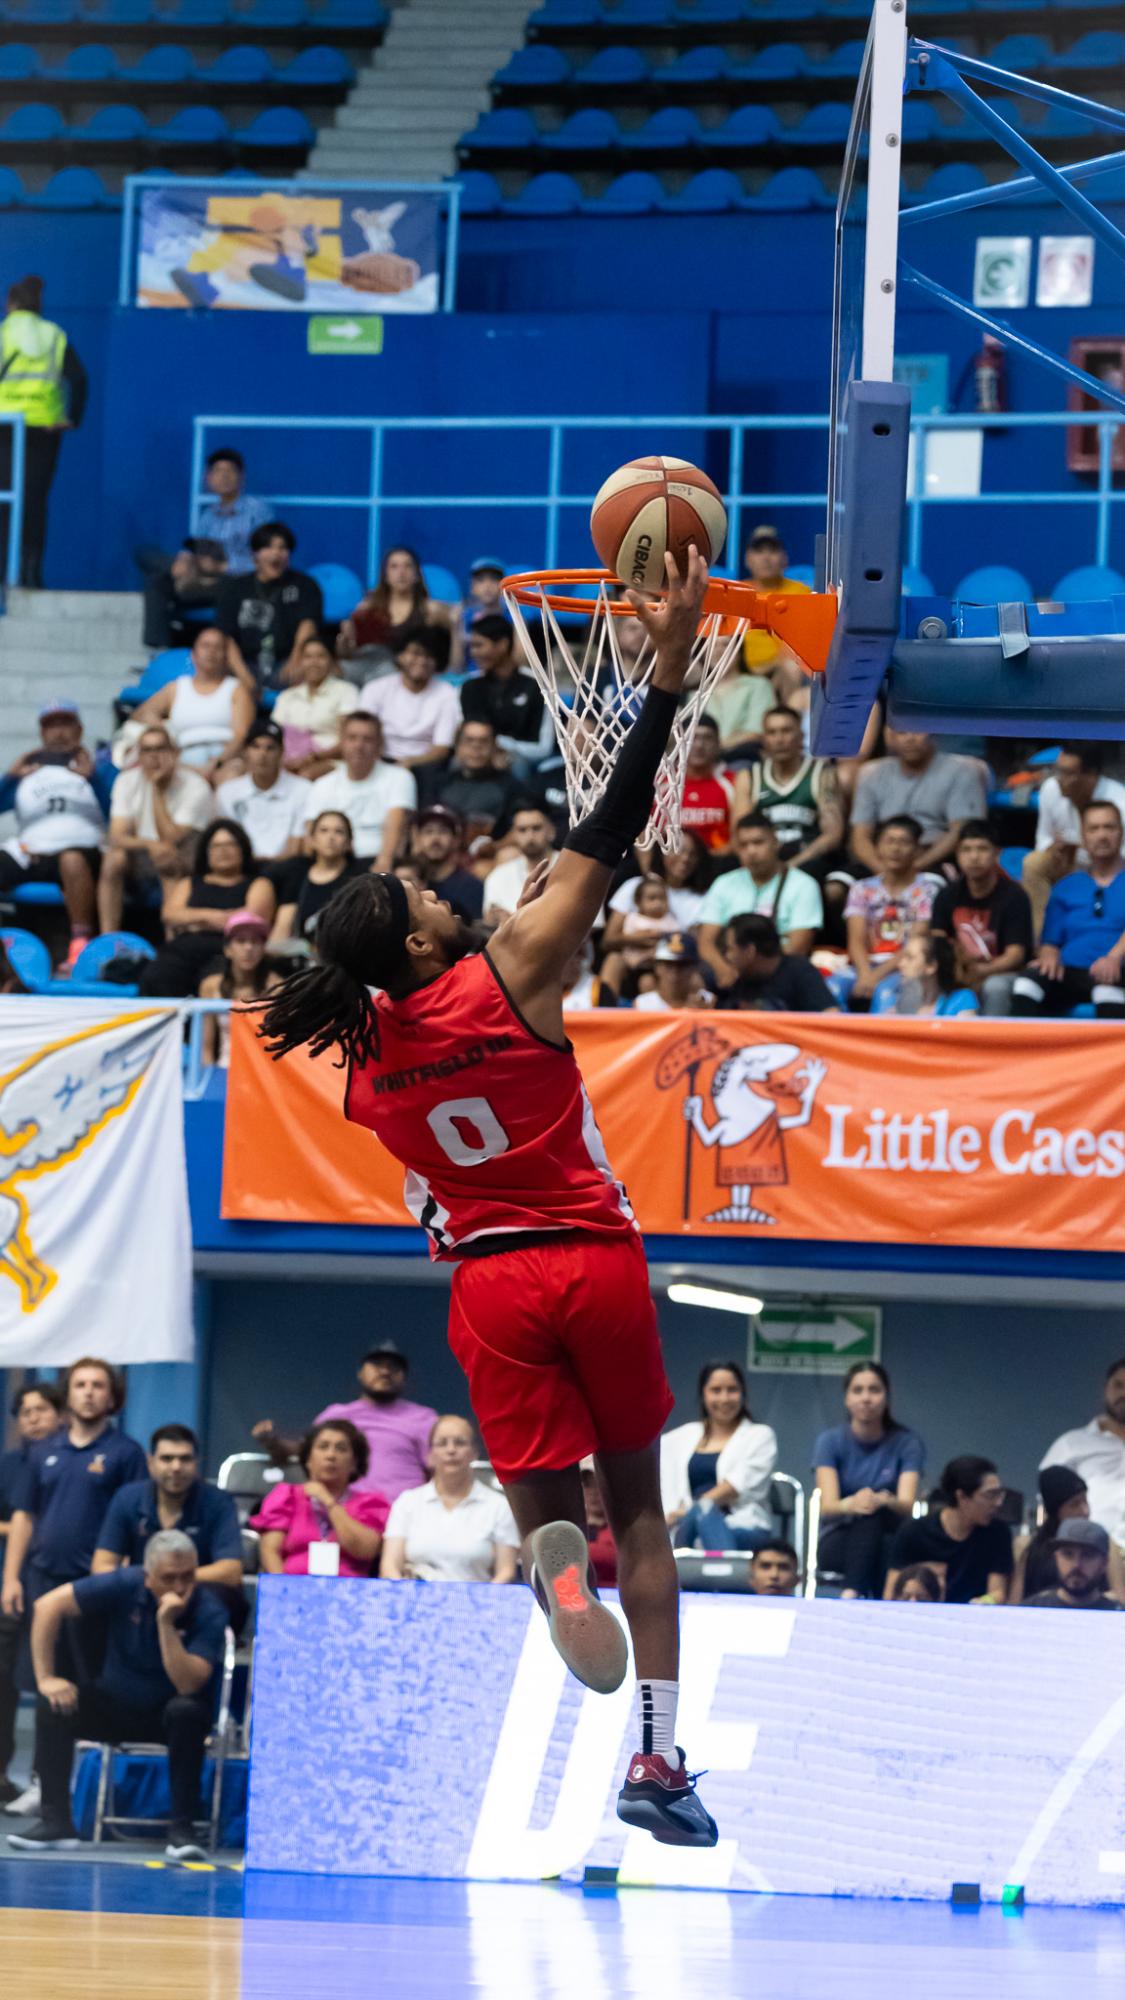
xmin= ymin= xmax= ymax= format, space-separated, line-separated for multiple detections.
xmin=98 ymin=722 xmax=214 ymax=930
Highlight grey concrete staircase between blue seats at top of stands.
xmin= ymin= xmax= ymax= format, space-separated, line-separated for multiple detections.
xmin=306 ymin=0 xmax=530 ymax=180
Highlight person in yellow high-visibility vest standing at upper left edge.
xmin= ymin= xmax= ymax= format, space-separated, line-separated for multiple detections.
xmin=0 ymin=278 xmax=86 ymax=590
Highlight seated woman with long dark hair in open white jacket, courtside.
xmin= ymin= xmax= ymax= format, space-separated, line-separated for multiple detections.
xmin=661 ymin=1362 xmax=777 ymax=1548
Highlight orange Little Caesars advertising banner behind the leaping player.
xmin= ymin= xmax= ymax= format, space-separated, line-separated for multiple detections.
xmin=222 ymin=1010 xmax=1125 ymax=1250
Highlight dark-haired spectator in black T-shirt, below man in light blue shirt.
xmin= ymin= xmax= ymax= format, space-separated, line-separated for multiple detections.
xmin=216 ymin=520 xmax=324 ymax=700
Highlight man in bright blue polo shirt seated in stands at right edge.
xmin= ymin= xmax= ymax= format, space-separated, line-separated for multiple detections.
xmin=1011 ymin=800 xmax=1125 ymax=1020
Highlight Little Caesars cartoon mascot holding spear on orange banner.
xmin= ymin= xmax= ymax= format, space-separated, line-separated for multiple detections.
xmin=683 ymin=1042 xmax=827 ymax=1222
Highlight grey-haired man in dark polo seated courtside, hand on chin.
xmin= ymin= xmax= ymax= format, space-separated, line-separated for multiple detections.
xmin=8 ymin=1528 xmax=226 ymax=1862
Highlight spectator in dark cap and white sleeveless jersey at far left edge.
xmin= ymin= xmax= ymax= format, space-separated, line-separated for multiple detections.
xmin=0 ymin=700 xmax=108 ymax=968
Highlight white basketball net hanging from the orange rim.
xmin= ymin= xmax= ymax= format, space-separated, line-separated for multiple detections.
xmin=504 ymin=584 xmax=749 ymax=854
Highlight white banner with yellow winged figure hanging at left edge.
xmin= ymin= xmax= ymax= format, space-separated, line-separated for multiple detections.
xmin=0 ymin=998 xmax=192 ymax=1368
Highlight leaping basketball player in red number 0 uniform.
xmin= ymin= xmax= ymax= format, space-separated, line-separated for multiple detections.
xmin=260 ymin=548 xmax=719 ymax=1848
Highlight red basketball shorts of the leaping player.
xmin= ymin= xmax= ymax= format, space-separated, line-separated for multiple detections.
xmin=448 ymin=1234 xmax=673 ymax=1480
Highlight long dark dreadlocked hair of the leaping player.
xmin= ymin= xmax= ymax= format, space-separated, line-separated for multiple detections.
xmin=258 ymin=874 xmax=404 ymax=1068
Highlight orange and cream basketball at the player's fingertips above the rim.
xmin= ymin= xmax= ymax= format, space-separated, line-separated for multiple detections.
xmin=591 ymin=458 xmax=727 ymax=590
